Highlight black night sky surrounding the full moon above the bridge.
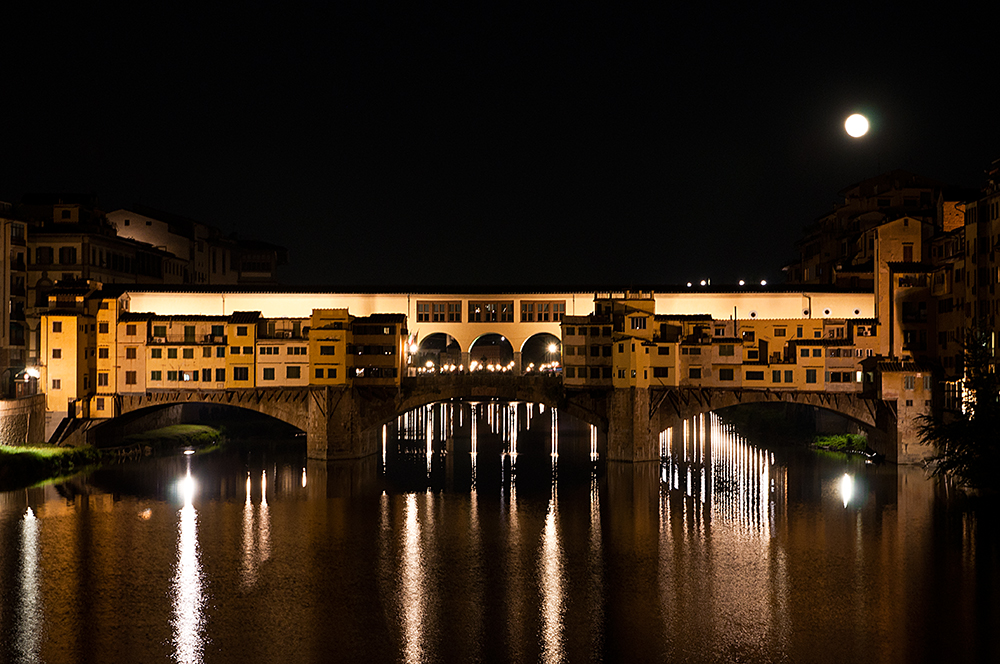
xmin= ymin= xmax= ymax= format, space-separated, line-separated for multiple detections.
xmin=0 ymin=0 xmax=1000 ymax=285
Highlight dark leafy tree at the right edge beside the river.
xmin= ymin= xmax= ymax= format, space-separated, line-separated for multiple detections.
xmin=918 ymin=330 xmax=1000 ymax=489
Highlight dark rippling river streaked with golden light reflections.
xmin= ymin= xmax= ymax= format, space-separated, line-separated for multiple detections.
xmin=0 ymin=405 xmax=1000 ymax=663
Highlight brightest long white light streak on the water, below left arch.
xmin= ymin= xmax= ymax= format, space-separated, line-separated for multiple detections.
xmin=171 ymin=461 xmax=205 ymax=664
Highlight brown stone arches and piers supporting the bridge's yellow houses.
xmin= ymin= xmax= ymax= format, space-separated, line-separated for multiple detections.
xmin=109 ymin=373 xmax=896 ymax=462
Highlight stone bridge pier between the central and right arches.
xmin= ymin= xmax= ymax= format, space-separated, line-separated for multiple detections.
xmin=608 ymin=387 xmax=660 ymax=463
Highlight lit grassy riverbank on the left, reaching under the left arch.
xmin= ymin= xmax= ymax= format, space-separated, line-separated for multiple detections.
xmin=0 ymin=424 xmax=225 ymax=491
